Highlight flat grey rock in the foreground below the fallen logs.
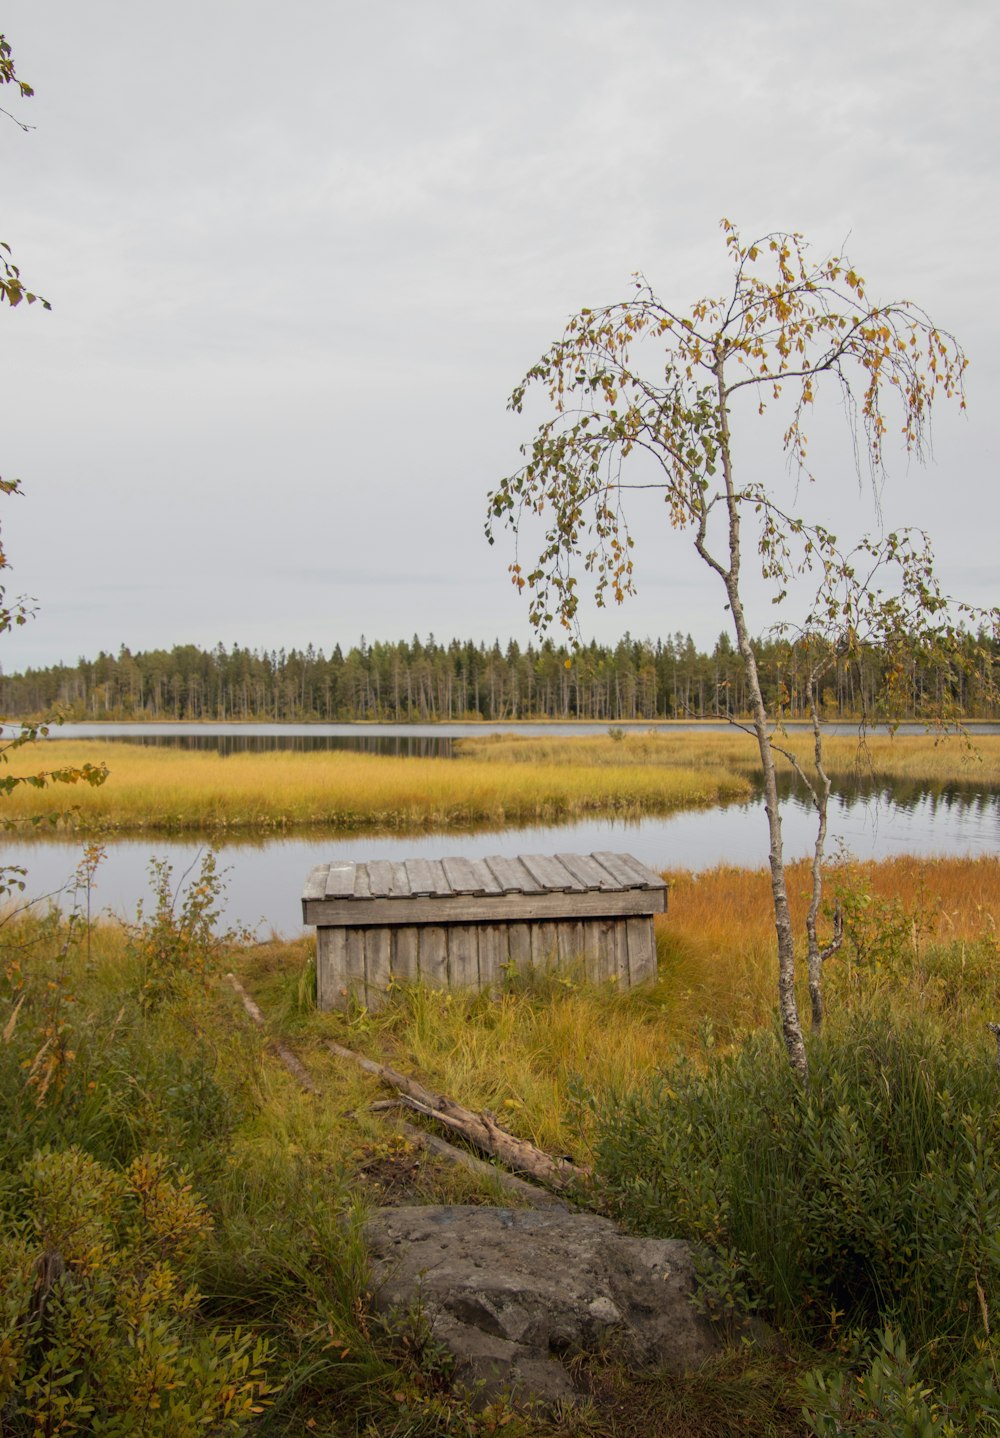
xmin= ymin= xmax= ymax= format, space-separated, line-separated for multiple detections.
xmin=365 ymin=1205 xmax=721 ymax=1402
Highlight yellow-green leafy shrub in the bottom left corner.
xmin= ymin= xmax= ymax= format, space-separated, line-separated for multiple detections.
xmin=0 ymin=1149 xmax=268 ymax=1438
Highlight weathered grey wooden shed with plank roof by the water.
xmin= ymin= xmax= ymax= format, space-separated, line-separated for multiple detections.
xmin=302 ymin=853 xmax=666 ymax=1008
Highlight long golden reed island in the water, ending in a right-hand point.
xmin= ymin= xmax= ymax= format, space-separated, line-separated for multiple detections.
xmin=3 ymin=741 xmax=750 ymax=833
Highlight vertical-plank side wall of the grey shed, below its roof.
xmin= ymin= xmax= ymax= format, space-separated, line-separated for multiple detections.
xmin=317 ymin=915 xmax=656 ymax=1009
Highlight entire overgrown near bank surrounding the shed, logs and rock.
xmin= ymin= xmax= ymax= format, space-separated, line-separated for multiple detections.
xmin=0 ymin=860 xmax=1000 ymax=1438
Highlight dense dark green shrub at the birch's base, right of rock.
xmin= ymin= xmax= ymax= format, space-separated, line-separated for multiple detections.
xmin=590 ymin=1017 xmax=1000 ymax=1369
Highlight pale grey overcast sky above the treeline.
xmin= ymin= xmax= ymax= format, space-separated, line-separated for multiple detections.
xmin=0 ymin=0 xmax=1000 ymax=672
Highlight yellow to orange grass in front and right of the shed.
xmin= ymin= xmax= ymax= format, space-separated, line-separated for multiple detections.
xmin=242 ymin=858 xmax=1000 ymax=1156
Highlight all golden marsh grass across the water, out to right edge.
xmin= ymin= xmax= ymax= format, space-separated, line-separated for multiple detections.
xmin=3 ymin=729 xmax=1000 ymax=833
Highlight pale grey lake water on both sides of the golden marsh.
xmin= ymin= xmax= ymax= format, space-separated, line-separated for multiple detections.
xmin=0 ymin=722 xmax=1000 ymax=935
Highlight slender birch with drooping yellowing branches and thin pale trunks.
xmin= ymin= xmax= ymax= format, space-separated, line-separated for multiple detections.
xmin=486 ymin=220 xmax=996 ymax=1077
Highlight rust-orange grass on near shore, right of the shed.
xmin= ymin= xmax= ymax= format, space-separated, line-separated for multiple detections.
xmin=658 ymin=856 xmax=1000 ymax=1053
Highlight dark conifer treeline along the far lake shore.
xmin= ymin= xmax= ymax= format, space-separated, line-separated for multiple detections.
xmin=0 ymin=634 xmax=1000 ymax=723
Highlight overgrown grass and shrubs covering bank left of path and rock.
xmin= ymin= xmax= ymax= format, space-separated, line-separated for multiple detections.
xmin=0 ymin=906 xmax=575 ymax=1438
